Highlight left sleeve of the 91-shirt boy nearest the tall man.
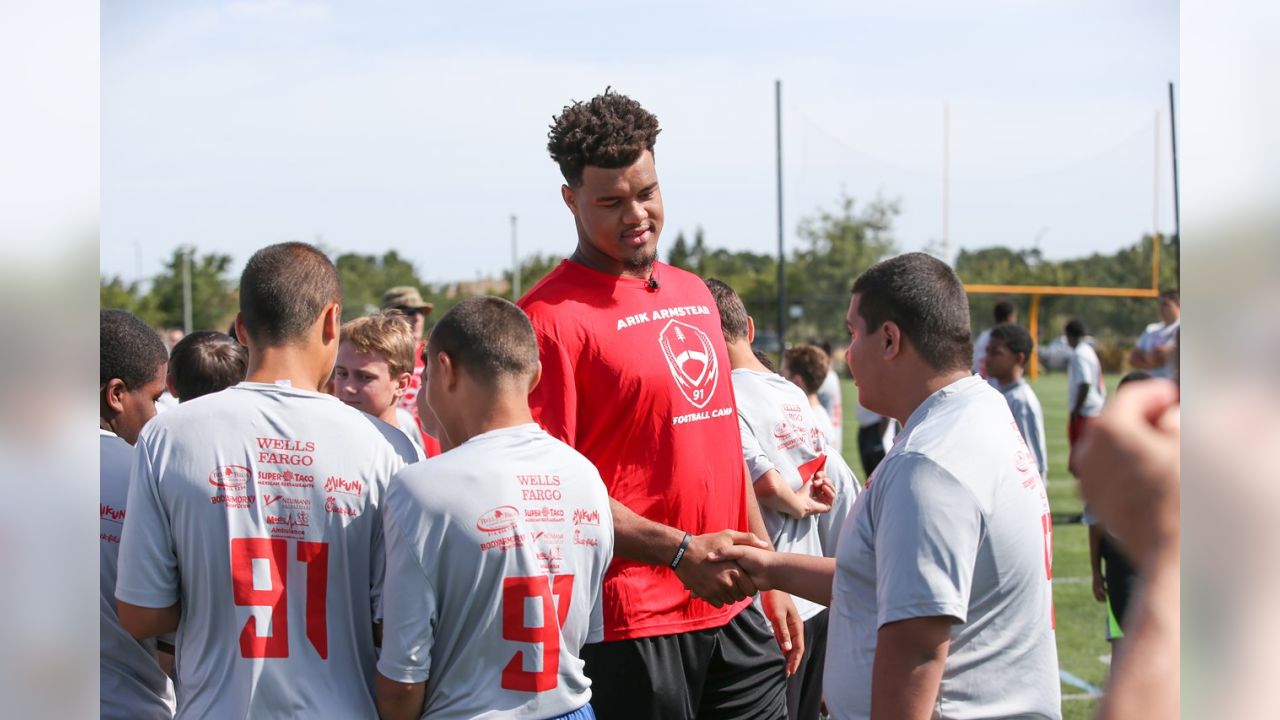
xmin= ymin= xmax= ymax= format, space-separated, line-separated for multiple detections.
xmin=378 ymin=482 xmax=438 ymax=683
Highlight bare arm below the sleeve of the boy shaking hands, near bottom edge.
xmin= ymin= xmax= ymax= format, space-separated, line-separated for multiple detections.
xmin=872 ymin=616 xmax=952 ymax=720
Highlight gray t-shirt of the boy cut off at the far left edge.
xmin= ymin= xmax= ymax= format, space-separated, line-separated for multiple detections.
xmin=97 ymin=430 xmax=174 ymax=720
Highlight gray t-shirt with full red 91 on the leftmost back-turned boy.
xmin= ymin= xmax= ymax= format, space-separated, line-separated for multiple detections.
xmin=115 ymin=382 xmax=417 ymax=717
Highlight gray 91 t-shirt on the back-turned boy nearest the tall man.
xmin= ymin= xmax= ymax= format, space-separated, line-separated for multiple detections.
xmin=378 ymin=423 xmax=613 ymax=720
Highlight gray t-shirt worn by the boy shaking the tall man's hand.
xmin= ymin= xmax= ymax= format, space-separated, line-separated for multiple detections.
xmin=824 ymin=375 xmax=1061 ymax=720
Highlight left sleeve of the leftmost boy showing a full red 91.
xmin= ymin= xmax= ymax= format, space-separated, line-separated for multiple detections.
xmin=115 ymin=434 xmax=179 ymax=607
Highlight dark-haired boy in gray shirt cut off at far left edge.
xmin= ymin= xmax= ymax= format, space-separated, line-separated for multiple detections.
xmin=99 ymin=310 xmax=174 ymax=720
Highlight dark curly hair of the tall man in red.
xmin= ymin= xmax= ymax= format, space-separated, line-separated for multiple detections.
xmin=547 ymin=88 xmax=662 ymax=187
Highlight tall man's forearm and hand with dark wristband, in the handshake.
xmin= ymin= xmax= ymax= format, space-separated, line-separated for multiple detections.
xmin=609 ymin=497 xmax=764 ymax=607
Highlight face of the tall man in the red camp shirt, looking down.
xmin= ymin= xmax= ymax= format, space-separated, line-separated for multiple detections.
xmin=564 ymin=150 xmax=663 ymax=277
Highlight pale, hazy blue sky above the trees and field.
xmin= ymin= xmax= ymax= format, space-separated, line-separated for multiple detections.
xmin=100 ymin=0 xmax=1179 ymax=282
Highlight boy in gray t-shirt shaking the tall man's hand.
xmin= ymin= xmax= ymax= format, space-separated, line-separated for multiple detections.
xmin=713 ymin=252 xmax=1062 ymax=720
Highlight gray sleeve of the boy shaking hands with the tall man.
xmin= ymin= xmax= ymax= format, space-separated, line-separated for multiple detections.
xmin=873 ymin=454 xmax=986 ymax=626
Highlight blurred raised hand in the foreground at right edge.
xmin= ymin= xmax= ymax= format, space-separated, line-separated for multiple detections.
xmin=1074 ymin=380 xmax=1181 ymax=566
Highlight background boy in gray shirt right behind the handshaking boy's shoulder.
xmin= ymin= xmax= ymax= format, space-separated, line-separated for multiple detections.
xmin=986 ymin=323 xmax=1048 ymax=483
